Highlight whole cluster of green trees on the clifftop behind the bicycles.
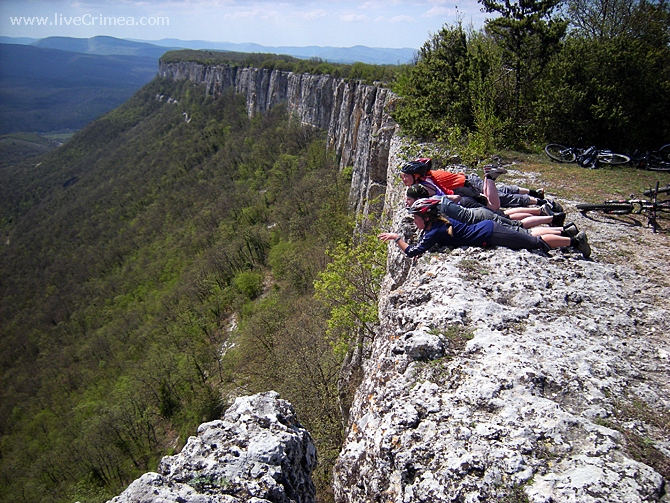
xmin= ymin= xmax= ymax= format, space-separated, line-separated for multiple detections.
xmin=393 ymin=0 xmax=670 ymax=158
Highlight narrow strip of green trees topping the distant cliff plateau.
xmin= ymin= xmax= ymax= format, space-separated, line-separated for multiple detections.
xmin=161 ymin=49 xmax=400 ymax=83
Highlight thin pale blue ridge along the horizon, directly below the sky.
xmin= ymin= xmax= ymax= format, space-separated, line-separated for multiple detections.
xmin=0 ymin=36 xmax=417 ymax=65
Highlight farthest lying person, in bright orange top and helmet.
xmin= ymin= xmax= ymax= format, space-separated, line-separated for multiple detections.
xmin=400 ymin=158 xmax=547 ymax=210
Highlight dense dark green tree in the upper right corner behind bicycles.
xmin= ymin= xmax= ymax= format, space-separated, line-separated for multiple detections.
xmin=533 ymin=0 xmax=670 ymax=149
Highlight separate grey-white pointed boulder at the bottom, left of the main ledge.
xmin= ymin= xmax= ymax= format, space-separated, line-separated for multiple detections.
xmin=111 ymin=391 xmax=316 ymax=503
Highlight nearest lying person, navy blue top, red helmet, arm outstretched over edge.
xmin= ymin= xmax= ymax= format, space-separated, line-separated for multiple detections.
xmin=377 ymin=198 xmax=591 ymax=258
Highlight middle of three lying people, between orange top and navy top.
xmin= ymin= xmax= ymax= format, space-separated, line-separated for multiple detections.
xmin=405 ymin=184 xmax=577 ymax=236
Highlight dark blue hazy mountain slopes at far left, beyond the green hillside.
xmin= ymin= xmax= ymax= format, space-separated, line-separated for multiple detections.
xmin=0 ymin=44 xmax=158 ymax=134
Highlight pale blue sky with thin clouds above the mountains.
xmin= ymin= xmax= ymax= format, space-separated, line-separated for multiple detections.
xmin=0 ymin=0 xmax=494 ymax=49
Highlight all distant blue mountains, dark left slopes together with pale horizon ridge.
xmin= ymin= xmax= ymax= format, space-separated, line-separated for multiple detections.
xmin=0 ymin=36 xmax=416 ymax=135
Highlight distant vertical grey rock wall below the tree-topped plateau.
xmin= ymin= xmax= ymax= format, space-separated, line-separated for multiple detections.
xmin=159 ymin=61 xmax=397 ymax=217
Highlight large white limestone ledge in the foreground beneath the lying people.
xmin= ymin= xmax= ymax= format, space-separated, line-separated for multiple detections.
xmin=334 ymin=144 xmax=670 ymax=503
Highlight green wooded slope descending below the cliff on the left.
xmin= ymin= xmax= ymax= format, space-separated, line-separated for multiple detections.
xmin=0 ymin=79 xmax=385 ymax=502
